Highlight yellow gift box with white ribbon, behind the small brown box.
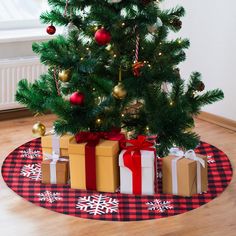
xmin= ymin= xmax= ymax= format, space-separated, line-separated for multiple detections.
xmin=41 ymin=134 xmax=73 ymax=160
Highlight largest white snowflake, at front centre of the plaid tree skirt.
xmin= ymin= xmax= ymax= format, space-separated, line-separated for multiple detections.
xmin=76 ymin=194 xmax=119 ymax=215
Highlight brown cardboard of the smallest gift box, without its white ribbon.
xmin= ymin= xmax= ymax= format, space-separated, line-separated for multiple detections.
xmin=41 ymin=160 xmax=69 ymax=184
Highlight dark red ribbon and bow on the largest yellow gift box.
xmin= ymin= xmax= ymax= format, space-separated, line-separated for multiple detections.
xmin=75 ymin=129 xmax=125 ymax=190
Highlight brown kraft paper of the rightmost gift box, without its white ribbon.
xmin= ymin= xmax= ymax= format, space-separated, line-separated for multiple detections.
xmin=162 ymin=154 xmax=208 ymax=197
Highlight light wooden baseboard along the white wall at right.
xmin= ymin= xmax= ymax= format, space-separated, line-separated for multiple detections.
xmin=197 ymin=111 xmax=236 ymax=131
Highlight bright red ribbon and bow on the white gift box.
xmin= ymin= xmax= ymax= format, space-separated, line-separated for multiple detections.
xmin=123 ymin=135 xmax=155 ymax=194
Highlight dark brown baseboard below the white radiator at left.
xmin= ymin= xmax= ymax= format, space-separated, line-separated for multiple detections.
xmin=0 ymin=108 xmax=33 ymax=121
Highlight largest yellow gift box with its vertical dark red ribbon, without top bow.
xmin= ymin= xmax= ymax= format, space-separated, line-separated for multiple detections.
xmin=69 ymin=136 xmax=119 ymax=192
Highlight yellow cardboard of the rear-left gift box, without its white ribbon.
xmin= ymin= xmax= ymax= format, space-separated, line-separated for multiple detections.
xmin=41 ymin=134 xmax=73 ymax=160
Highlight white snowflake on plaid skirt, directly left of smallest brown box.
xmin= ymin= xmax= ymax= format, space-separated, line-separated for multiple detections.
xmin=20 ymin=164 xmax=42 ymax=181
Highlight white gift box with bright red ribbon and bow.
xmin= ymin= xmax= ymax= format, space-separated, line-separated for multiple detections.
xmin=119 ymin=136 xmax=156 ymax=195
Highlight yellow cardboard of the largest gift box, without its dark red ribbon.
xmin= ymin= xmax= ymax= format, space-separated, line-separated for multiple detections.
xmin=69 ymin=139 xmax=119 ymax=192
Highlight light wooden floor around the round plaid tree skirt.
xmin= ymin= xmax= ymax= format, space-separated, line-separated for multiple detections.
xmin=0 ymin=116 xmax=236 ymax=236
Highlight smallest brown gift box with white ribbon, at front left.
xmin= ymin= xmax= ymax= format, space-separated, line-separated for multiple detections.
xmin=41 ymin=156 xmax=69 ymax=184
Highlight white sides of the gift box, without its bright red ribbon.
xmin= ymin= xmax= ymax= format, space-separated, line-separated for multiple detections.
xmin=119 ymin=150 xmax=156 ymax=195
